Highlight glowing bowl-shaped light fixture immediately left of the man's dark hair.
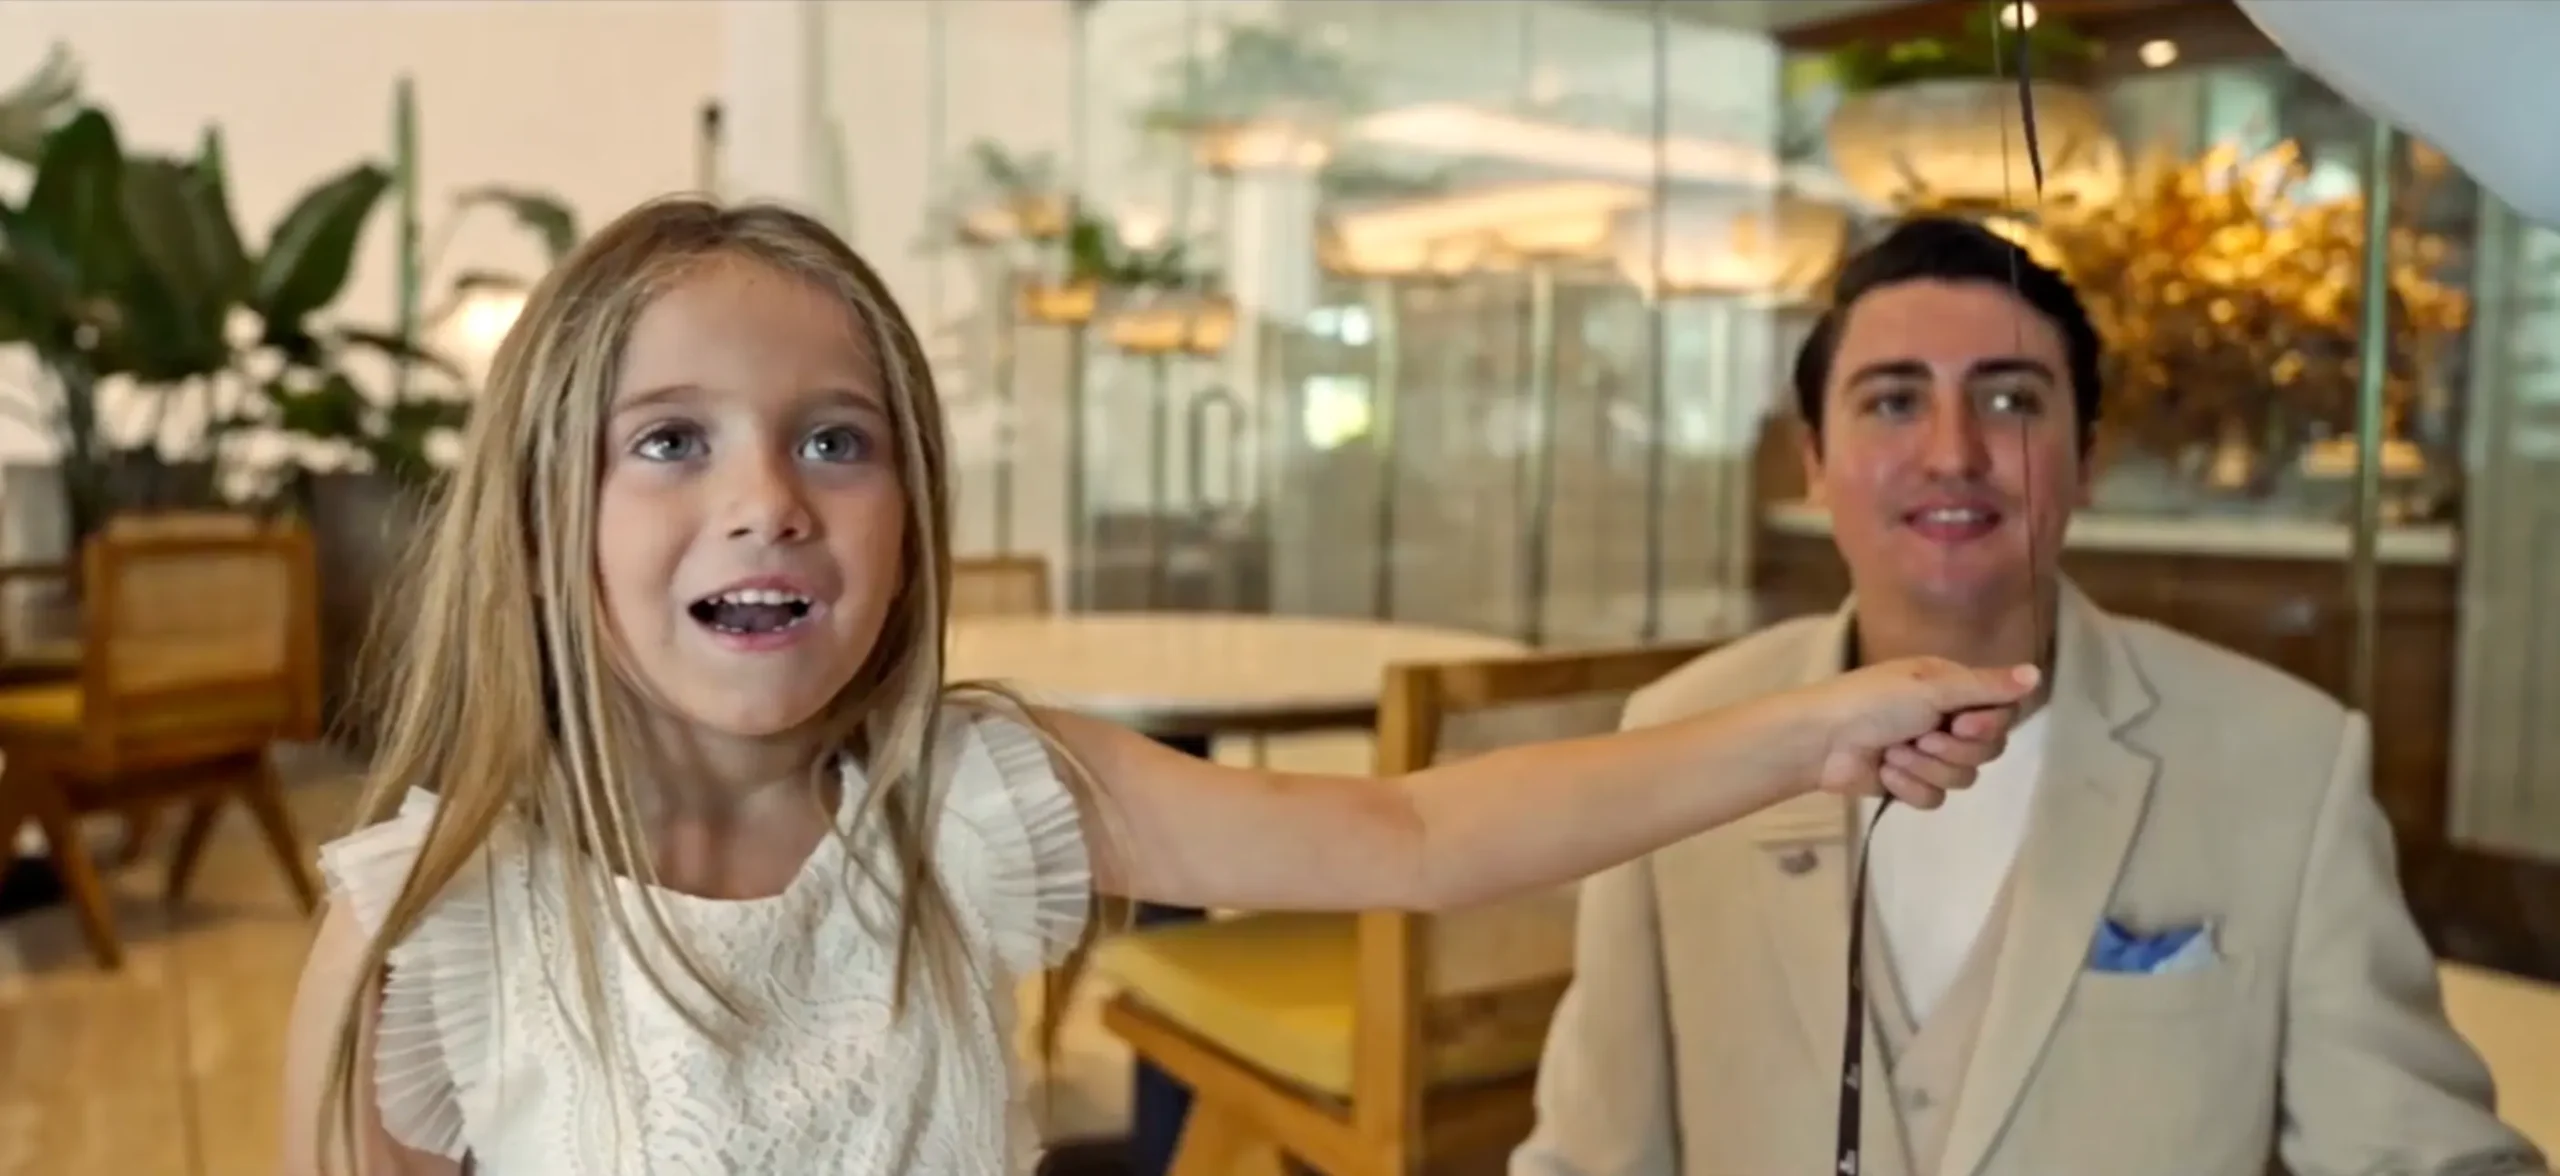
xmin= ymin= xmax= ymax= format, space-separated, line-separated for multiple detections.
xmin=1610 ymin=192 xmax=1848 ymax=302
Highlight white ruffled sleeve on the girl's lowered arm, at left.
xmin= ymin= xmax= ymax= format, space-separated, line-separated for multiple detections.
xmin=320 ymin=792 xmax=494 ymax=1161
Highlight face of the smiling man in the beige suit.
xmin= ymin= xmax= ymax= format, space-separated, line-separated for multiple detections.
xmin=1805 ymin=279 xmax=2089 ymax=623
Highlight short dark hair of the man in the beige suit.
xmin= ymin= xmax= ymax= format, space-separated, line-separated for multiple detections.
xmin=1795 ymin=218 xmax=2099 ymax=451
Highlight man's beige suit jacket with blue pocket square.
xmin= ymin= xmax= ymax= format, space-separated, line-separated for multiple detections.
xmin=1510 ymin=589 xmax=2547 ymax=1176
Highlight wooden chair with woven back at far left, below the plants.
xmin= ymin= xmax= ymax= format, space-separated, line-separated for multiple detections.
xmin=0 ymin=528 xmax=320 ymax=968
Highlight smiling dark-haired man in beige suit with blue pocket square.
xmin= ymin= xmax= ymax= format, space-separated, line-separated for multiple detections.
xmin=1510 ymin=220 xmax=2547 ymax=1176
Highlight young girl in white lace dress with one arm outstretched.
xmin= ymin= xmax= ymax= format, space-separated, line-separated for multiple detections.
xmin=284 ymin=200 xmax=2035 ymax=1176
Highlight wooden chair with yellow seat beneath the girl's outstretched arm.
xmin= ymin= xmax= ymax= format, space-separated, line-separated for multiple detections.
xmin=1096 ymin=646 xmax=1708 ymax=1176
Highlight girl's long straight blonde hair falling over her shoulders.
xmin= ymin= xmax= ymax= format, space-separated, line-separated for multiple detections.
xmin=320 ymin=197 xmax=1085 ymax=1173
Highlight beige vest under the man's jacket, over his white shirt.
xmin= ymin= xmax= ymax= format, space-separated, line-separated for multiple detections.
xmin=1866 ymin=884 xmax=2010 ymax=1176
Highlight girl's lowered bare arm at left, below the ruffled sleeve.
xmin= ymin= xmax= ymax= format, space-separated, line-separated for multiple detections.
xmin=279 ymin=902 xmax=463 ymax=1176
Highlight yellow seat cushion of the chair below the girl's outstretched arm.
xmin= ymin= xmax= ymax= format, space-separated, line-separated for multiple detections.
xmin=1093 ymin=915 xmax=1544 ymax=1099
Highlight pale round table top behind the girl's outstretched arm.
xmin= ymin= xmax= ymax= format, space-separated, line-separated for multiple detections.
xmin=947 ymin=612 xmax=1526 ymax=735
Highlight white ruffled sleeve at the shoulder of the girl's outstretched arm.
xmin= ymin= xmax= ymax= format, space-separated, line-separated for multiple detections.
xmin=942 ymin=715 xmax=1093 ymax=976
